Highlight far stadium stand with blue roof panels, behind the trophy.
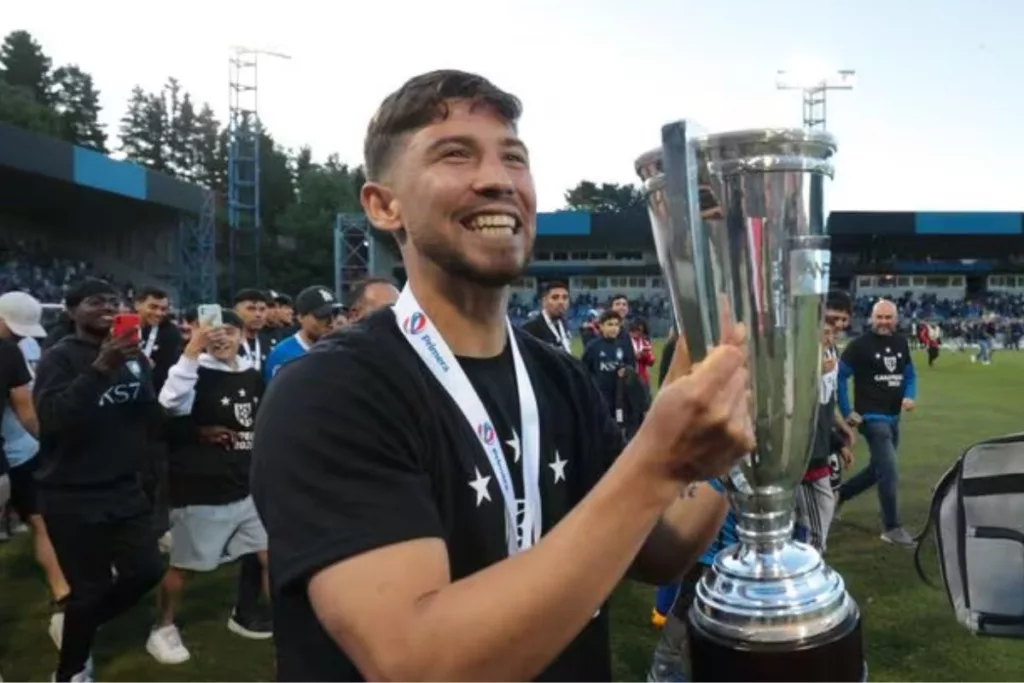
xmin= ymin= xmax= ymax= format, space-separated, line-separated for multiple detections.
xmin=378 ymin=204 xmax=1024 ymax=345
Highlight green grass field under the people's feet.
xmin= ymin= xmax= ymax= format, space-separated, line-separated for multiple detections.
xmin=0 ymin=349 xmax=1024 ymax=681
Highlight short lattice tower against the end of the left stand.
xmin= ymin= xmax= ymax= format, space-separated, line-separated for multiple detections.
xmin=177 ymin=190 xmax=217 ymax=306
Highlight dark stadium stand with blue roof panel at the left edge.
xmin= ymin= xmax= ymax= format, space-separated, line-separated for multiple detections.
xmin=0 ymin=124 xmax=216 ymax=311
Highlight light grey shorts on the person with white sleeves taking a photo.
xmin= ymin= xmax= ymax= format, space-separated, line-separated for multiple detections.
xmin=170 ymin=496 xmax=266 ymax=571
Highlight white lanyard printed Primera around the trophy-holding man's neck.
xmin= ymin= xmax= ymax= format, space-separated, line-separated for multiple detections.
xmin=394 ymin=285 xmax=542 ymax=556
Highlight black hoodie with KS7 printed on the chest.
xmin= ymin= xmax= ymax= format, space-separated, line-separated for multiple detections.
xmin=33 ymin=336 xmax=163 ymax=521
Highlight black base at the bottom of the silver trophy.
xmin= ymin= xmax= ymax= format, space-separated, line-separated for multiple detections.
xmin=688 ymin=609 xmax=867 ymax=681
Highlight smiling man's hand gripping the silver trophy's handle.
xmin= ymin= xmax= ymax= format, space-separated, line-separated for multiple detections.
xmin=636 ymin=317 xmax=755 ymax=482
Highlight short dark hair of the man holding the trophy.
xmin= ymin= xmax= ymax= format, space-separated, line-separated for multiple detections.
xmin=362 ymin=69 xmax=522 ymax=180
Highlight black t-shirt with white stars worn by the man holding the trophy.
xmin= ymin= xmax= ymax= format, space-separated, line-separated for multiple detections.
xmin=253 ymin=309 xmax=622 ymax=681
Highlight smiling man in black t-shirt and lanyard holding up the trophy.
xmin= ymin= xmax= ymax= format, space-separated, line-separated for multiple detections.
xmin=253 ymin=71 xmax=753 ymax=681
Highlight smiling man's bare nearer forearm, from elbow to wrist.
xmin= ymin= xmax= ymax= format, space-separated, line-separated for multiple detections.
xmin=399 ymin=441 xmax=679 ymax=681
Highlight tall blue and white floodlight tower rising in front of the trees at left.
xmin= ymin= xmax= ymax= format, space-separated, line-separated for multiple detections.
xmin=227 ymin=47 xmax=291 ymax=296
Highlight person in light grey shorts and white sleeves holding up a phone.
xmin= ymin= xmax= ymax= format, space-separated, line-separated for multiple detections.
xmin=145 ymin=313 xmax=272 ymax=665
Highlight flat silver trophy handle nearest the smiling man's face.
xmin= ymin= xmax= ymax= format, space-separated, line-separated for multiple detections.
xmin=655 ymin=120 xmax=718 ymax=362
